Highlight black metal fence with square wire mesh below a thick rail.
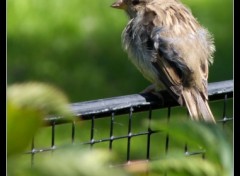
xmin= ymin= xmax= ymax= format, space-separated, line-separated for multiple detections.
xmin=26 ymin=80 xmax=233 ymax=165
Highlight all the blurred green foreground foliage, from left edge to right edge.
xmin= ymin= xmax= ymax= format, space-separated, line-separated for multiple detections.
xmin=7 ymin=82 xmax=233 ymax=176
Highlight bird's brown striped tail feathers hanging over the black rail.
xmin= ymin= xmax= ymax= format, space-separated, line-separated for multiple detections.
xmin=182 ymin=89 xmax=216 ymax=123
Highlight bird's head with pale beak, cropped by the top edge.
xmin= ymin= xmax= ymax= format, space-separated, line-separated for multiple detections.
xmin=111 ymin=0 xmax=149 ymax=18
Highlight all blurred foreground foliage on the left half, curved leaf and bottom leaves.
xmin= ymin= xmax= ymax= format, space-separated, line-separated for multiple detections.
xmin=7 ymin=82 xmax=126 ymax=176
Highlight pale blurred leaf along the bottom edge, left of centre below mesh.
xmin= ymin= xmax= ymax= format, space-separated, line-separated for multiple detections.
xmin=8 ymin=147 xmax=129 ymax=176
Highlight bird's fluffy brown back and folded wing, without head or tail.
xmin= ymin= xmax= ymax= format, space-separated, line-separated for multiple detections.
xmin=144 ymin=2 xmax=212 ymax=104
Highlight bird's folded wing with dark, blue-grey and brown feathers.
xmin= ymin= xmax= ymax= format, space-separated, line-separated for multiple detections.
xmin=151 ymin=27 xmax=191 ymax=105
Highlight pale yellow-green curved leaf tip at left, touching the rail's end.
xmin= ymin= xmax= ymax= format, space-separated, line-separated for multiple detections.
xmin=7 ymin=82 xmax=73 ymax=117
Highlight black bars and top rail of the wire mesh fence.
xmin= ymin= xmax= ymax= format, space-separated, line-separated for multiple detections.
xmin=26 ymin=80 xmax=233 ymax=165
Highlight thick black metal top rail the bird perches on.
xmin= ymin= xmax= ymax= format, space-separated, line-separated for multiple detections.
xmin=45 ymin=80 xmax=233 ymax=124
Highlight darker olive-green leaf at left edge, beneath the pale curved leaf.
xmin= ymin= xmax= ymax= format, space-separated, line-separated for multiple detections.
xmin=7 ymin=100 xmax=43 ymax=156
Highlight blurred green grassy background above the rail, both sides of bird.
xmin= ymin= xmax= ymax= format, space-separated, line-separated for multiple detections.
xmin=7 ymin=0 xmax=233 ymax=102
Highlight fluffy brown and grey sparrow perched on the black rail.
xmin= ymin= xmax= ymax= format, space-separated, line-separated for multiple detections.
xmin=111 ymin=0 xmax=216 ymax=123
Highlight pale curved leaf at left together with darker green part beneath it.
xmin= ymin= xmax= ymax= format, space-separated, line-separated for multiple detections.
xmin=7 ymin=82 xmax=73 ymax=156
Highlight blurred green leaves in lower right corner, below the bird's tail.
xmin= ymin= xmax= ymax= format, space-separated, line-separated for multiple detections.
xmin=147 ymin=121 xmax=233 ymax=176
